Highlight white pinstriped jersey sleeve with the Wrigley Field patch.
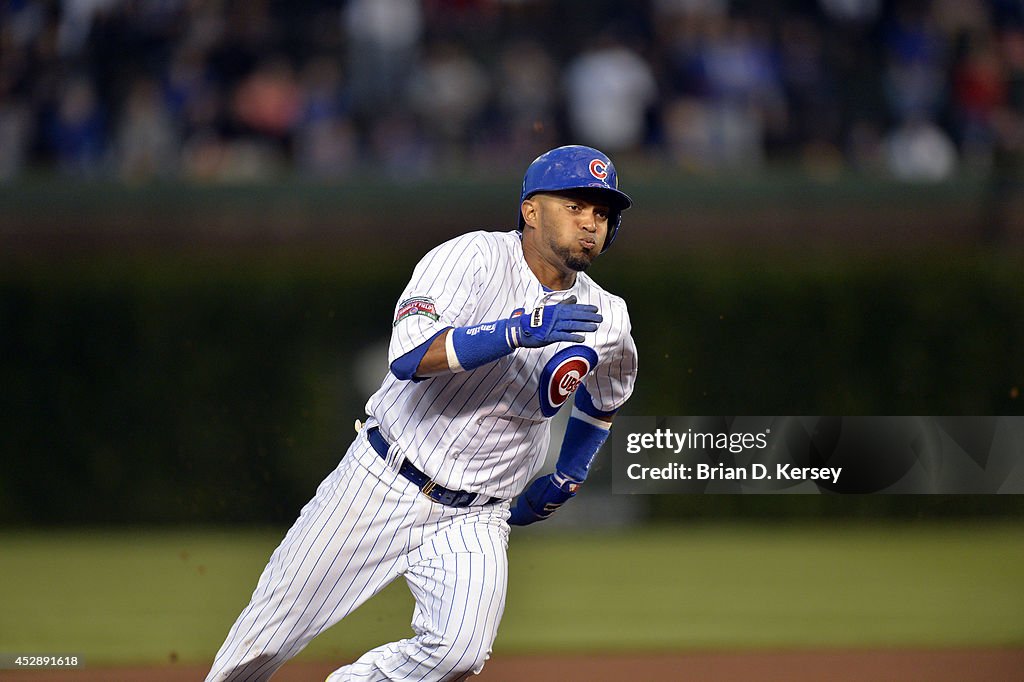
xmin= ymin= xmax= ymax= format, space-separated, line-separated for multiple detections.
xmin=388 ymin=233 xmax=487 ymax=364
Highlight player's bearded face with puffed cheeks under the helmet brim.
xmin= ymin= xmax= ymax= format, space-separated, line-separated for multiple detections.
xmin=534 ymin=191 xmax=610 ymax=272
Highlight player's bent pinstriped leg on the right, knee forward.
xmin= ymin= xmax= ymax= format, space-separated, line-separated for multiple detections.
xmin=328 ymin=507 xmax=508 ymax=682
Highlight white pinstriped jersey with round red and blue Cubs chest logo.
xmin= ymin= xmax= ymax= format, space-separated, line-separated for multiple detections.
xmin=367 ymin=230 xmax=637 ymax=499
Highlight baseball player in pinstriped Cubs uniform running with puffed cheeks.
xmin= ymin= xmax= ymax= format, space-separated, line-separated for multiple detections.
xmin=207 ymin=146 xmax=637 ymax=682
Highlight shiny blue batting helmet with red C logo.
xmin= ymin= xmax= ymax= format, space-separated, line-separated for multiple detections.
xmin=518 ymin=144 xmax=633 ymax=252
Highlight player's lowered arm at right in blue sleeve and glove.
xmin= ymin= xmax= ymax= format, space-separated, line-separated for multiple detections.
xmin=509 ymin=386 xmax=611 ymax=525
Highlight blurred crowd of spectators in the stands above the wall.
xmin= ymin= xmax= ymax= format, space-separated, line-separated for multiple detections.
xmin=0 ymin=0 xmax=1024 ymax=181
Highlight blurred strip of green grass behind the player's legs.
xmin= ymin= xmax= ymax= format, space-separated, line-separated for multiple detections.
xmin=0 ymin=523 xmax=1024 ymax=666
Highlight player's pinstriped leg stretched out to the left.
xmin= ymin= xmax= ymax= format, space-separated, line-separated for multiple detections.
xmin=207 ymin=437 xmax=416 ymax=682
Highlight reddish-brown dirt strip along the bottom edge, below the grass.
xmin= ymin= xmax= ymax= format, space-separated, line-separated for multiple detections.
xmin=8 ymin=649 xmax=1024 ymax=682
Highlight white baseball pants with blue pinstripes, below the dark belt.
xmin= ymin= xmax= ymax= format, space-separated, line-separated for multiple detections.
xmin=207 ymin=433 xmax=509 ymax=682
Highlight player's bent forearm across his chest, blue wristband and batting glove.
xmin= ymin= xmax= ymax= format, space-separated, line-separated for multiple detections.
xmin=405 ymin=296 xmax=603 ymax=379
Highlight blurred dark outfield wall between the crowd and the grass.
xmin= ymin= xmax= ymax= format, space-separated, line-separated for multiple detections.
xmin=0 ymin=178 xmax=1024 ymax=525
